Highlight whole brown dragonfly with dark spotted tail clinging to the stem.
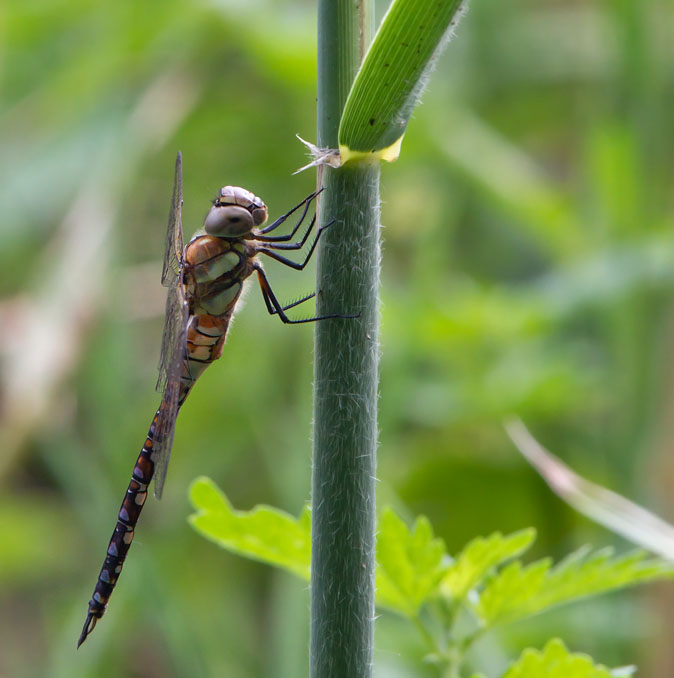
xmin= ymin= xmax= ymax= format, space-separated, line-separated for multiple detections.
xmin=77 ymin=153 xmax=342 ymax=648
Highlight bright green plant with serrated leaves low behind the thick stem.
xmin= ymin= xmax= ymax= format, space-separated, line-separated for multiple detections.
xmin=189 ymin=484 xmax=674 ymax=678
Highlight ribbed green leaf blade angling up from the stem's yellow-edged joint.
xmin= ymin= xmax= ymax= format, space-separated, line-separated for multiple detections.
xmin=339 ymin=0 xmax=462 ymax=162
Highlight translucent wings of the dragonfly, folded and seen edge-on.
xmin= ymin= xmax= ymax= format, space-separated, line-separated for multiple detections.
xmin=154 ymin=153 xmax=189 ymax=499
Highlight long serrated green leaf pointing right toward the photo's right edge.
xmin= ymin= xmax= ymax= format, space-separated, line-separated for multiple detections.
xmin=476 ymin=548 xmax=674 ymax=624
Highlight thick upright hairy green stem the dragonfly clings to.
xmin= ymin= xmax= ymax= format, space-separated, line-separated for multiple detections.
xmin=310 ymin=0 xmax=380 ymax=678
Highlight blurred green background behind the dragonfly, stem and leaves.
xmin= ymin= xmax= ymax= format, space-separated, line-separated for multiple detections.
xmin=0 ymin=0 xmax=674 ymax=678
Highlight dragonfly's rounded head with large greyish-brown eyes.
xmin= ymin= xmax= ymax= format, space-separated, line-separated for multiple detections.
xmin=204 ymin=186 xmax=267 ymax=238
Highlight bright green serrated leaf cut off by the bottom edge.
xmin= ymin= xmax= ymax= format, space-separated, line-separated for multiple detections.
xmin=503 ymin=639 xmax=625 ymax=678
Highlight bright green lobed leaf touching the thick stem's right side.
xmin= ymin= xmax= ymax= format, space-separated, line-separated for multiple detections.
xmin=377 ymin=508 xmax=447 ymax=617
